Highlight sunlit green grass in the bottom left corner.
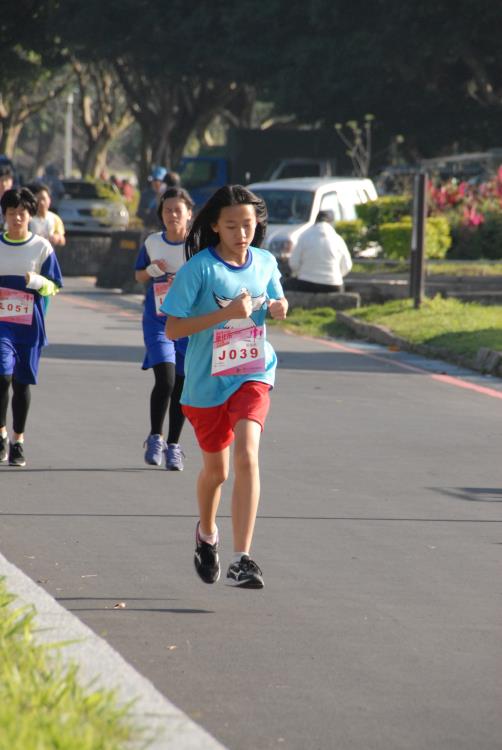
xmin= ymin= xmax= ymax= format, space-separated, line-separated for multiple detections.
xmin=0 ymin=579 xmax=140 ymax=750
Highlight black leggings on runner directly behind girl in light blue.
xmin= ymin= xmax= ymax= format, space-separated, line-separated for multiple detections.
xmin=150 ymin=362 xmax=185 ymax=443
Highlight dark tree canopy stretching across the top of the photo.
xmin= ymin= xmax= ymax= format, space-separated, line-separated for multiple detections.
xmin=0 ymin=0 xmax=502 ymax=178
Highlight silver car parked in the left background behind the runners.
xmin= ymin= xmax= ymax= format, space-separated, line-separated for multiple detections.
xmin=54 ymin=179 xmax=129 ymax=234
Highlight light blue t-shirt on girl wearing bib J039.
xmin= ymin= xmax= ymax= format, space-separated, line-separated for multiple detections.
xmin=161 ymin=247 xmax=284 ymax=407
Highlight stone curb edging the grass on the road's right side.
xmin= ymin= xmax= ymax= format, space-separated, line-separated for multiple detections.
xmin=336 ymin=311 xmax=502 ymax=378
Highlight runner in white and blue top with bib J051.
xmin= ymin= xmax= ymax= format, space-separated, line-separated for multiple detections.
xmin=0 ymin=188 xmax=62 ymax=466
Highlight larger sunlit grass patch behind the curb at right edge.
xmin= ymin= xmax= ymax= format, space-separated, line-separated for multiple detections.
xmin=349 ymin=295 xmax=502 ymax=357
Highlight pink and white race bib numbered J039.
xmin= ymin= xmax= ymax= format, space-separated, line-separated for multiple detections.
xmin=211 ymin=325 xmax=265 ymax=375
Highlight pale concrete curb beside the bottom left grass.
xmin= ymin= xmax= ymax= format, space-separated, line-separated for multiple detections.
xmin=0 ymin=554 xmax=225 ymax=750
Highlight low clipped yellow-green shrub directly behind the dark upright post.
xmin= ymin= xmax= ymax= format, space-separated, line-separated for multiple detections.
xmin=380 ymin=216 xmax=451 ymax=260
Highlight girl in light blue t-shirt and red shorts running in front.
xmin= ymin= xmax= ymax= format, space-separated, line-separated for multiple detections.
xmin=161 ymin=185 xmax=288 ymax=588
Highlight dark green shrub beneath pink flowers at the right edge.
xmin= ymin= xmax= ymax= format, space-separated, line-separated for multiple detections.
xmin=448 ymin=212 xmax=502 ymax=260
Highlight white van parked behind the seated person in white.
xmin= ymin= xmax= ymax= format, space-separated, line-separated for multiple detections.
xmin=248 ymin=177 xmax=378 ymax=273
